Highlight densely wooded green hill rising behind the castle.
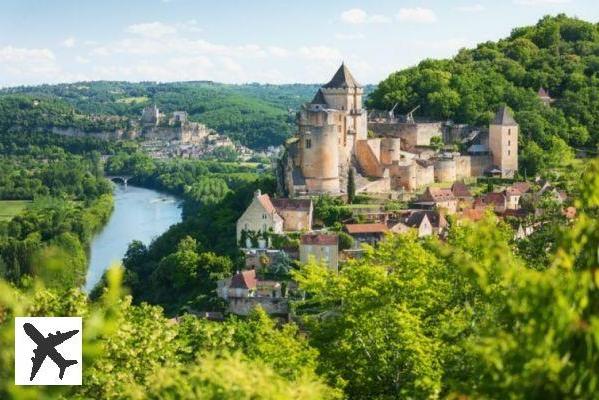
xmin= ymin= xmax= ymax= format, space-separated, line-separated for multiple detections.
xmin=369 ymin=14 xmax=599 ymax=173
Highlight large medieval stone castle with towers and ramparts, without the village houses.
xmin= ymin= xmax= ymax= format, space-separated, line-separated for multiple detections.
xmin=279 ymin=64 xmax=518 ymax=196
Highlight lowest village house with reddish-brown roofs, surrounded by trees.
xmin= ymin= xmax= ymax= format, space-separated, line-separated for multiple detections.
xmin=216 ymin=270 xmax=289 ymax=315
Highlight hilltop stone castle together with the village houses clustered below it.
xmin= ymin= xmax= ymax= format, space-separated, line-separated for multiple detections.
xmin=217 ymin=65 xmax=576 ymax=317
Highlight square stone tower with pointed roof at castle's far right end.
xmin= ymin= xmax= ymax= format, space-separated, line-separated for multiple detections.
xmin=489 ymin=106 xmax=518 ymax=178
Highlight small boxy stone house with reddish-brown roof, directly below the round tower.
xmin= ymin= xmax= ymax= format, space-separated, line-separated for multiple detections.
xmin=299 ymin=233 xmax=339 ymax=272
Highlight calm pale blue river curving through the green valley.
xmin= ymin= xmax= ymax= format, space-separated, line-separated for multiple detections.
xmin=85 ymin=185 xmax=181 ymax=292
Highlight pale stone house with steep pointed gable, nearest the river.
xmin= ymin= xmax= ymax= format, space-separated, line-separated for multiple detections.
xmin=237 ymin=190 xmax=284 ymax=247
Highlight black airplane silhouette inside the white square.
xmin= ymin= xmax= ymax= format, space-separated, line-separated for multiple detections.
xmin=23 ymin=322 xmax=79 ymax=381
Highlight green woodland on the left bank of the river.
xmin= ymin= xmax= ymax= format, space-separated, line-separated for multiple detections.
xmin=0 ymin=134 xmax=112 ymax=289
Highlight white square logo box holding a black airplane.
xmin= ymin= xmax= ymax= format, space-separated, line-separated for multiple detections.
xmin=15 ymin=317 xmax=83 ymax=385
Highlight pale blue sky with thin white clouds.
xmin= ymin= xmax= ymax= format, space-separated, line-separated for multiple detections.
xmin=0 ymin=0 xmax=599 ymax=87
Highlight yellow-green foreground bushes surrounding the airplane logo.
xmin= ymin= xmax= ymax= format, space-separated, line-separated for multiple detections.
xmin=0 ymin=269 xmax=339 ymax=400
